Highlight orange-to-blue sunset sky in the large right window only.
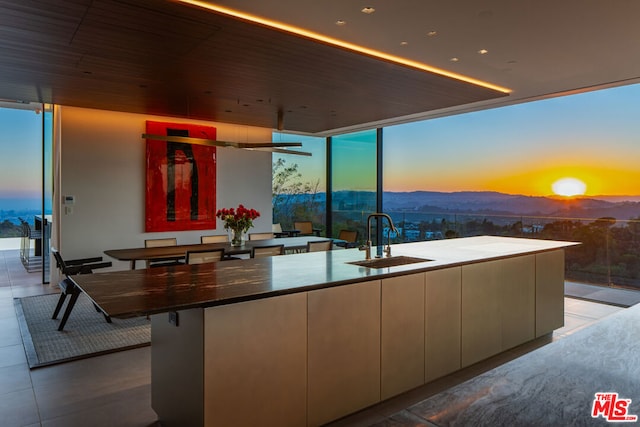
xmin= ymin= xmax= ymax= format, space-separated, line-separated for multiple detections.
xmin=384 ymin=85 xmax=640 ymax=196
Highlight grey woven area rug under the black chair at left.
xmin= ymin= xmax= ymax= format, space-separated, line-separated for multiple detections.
xmin=14 ymin=294 xmax=151 ymax=368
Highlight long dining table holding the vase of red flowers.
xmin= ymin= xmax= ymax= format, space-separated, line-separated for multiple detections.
xmin=104 ymin=236 xmax=335 ymax=270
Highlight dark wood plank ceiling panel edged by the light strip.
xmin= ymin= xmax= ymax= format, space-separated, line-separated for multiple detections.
xmin=0 ymin=0 xmax=505 ymax=134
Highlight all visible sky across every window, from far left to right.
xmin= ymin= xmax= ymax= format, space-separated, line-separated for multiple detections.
xmin=0 ymin=84 xmax=640 ymax=209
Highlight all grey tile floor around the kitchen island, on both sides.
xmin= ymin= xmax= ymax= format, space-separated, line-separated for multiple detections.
xmin=0 ymin=250 xmax=632 ymax=427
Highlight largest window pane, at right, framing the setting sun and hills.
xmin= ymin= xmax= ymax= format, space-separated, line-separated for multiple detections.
xmin=383 ymin=84 xmax=640 ymax=287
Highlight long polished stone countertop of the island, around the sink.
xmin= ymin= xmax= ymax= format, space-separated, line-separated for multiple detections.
xmin=72 ymin=236 xmax=579 ymax=318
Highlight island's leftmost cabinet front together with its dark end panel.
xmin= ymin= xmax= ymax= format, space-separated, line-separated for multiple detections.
xmin=151 ymin=293 xmax=307 ymax=426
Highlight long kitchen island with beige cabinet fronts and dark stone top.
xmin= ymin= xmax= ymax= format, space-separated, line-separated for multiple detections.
xmin=74 ymin=236 xmax=574 ymax=426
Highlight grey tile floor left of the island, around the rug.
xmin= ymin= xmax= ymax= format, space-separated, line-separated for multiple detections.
xmin=0 ymin=250 xmax=160 ymax=427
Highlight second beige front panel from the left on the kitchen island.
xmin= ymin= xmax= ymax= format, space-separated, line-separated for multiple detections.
xmin=307 ymin=280 xmax=380 ymax=426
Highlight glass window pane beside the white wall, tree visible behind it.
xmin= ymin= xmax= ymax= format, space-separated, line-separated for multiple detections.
xmin=272 ymin=133 xmax=327 ymax=231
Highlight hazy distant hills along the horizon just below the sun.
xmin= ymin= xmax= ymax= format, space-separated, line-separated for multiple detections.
xmin=384 ymin=191 xmax=640 ymax=219
